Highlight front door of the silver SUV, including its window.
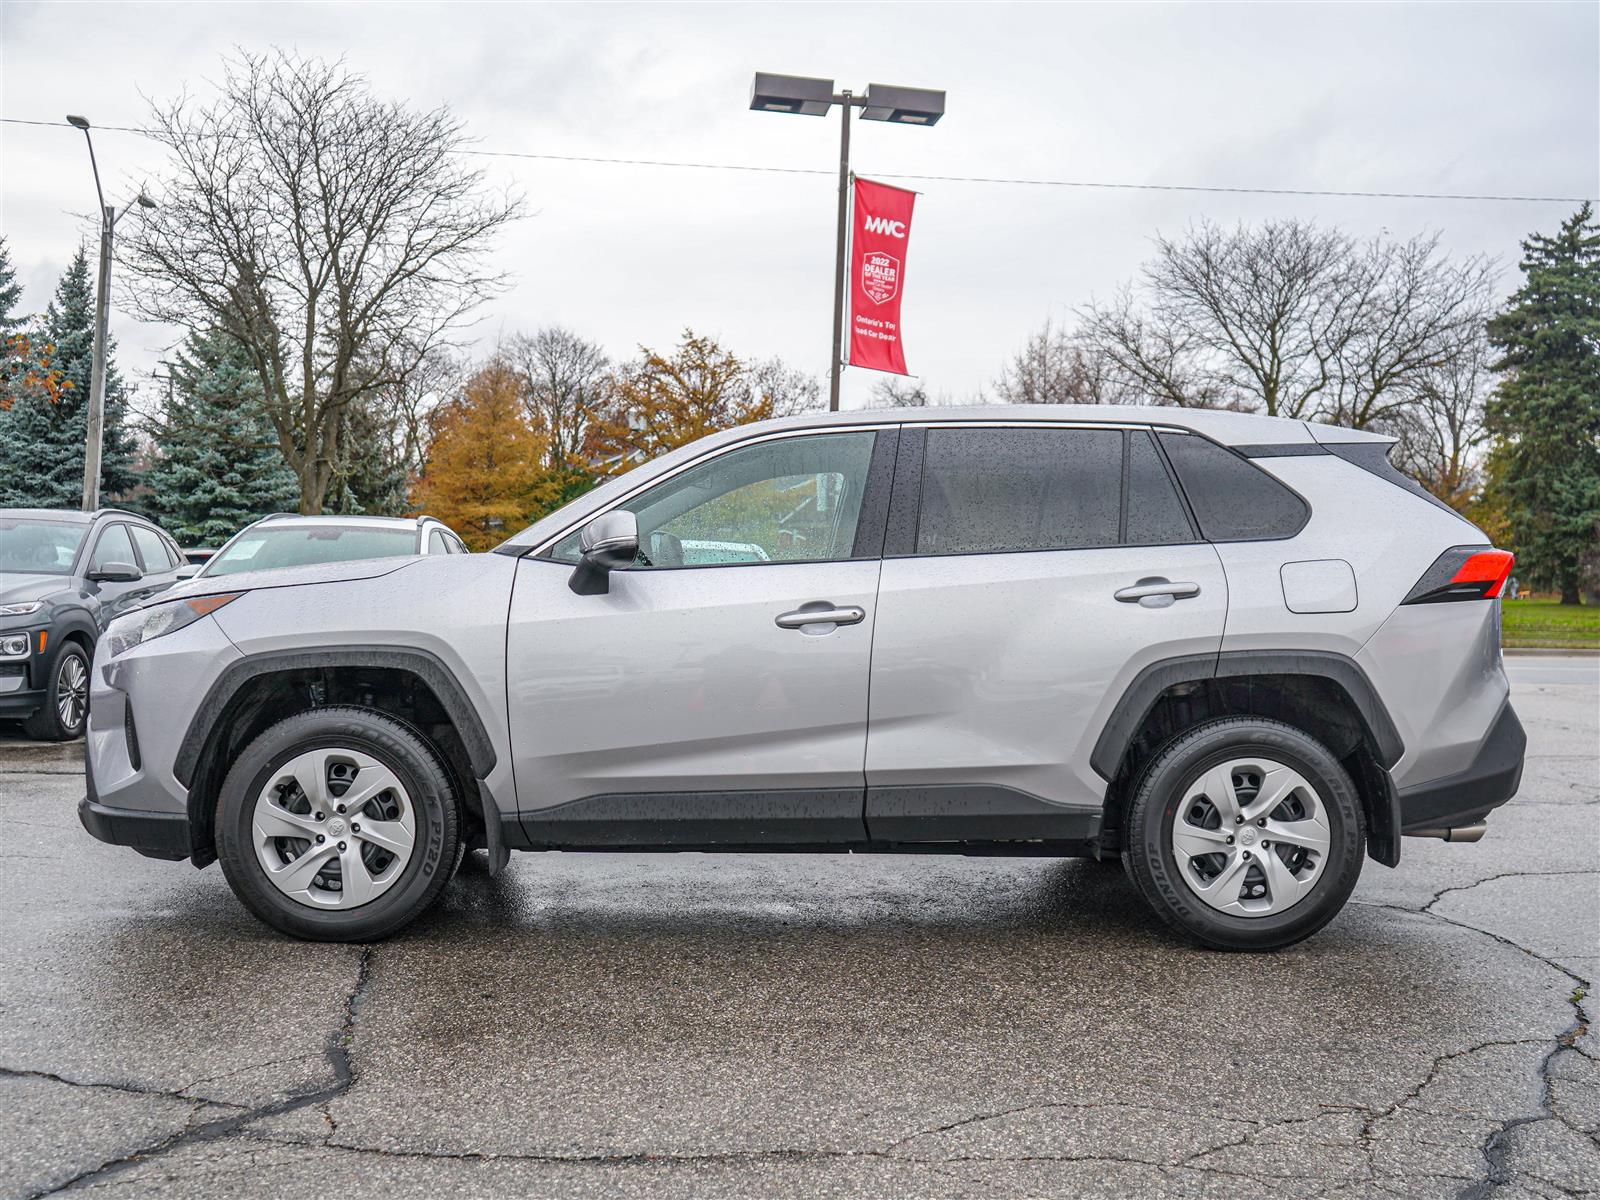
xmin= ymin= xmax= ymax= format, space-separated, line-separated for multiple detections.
xmin=507 ymin=430 xmax=894 ymax=845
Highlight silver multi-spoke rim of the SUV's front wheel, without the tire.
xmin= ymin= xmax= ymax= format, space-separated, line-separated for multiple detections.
xmin=251 ymin=749 xmax=416 ymax=909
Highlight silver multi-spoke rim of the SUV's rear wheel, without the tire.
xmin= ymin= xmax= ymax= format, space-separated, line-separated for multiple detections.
xmin=1170 ymin=757 xmax=1333 ymax=917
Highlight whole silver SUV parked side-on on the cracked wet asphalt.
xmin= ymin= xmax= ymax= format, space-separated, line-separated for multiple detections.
xmin=82 ymin=408 xmax=1525 ymax=949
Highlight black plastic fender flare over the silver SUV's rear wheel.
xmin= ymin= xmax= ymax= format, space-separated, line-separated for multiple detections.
xmin=1090 ymin=650 xmax=1405 ymax=781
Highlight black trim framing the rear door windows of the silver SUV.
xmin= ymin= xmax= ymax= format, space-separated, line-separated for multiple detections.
xmin=883 ymin=419 xmax=1203 ymax=558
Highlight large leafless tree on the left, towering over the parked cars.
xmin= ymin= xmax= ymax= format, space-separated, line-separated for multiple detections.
xmin=123 ymin=50 xmax=518 ymax=512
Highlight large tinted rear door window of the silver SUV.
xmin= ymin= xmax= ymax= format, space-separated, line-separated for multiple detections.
xmin=917 ymin=427 xmax=1123 ymax=554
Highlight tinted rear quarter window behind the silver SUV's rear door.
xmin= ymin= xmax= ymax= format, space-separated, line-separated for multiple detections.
xmin=1160 ymin=432 xmax=1310 ymax=542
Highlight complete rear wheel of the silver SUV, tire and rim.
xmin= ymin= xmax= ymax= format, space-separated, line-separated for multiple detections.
xmin=1123 ymin=717 xmax=1366 ymax=950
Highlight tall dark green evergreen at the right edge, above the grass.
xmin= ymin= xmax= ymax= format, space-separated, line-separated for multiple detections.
xmin=1488 ymin=202 xmax=1600 ymax=605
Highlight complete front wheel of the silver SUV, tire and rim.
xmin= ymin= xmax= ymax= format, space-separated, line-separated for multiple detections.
xmin=216 ymin=707 xmax=461 ymax=942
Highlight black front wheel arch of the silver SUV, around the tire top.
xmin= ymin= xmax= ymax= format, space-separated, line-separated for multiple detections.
xmin=173 ymin=646 xmax=502 ymax=867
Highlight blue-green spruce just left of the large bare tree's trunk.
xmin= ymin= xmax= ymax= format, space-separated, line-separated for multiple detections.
xmin=144 ymin=321 xmax=299 ymax=546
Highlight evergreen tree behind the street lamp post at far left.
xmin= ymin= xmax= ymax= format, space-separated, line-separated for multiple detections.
xmin=0 ymin=248 xmax=138 ymax=509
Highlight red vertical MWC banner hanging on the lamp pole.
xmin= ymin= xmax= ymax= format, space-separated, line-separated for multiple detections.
xmin=850 ymin=179 xmax=917 ymax=374
